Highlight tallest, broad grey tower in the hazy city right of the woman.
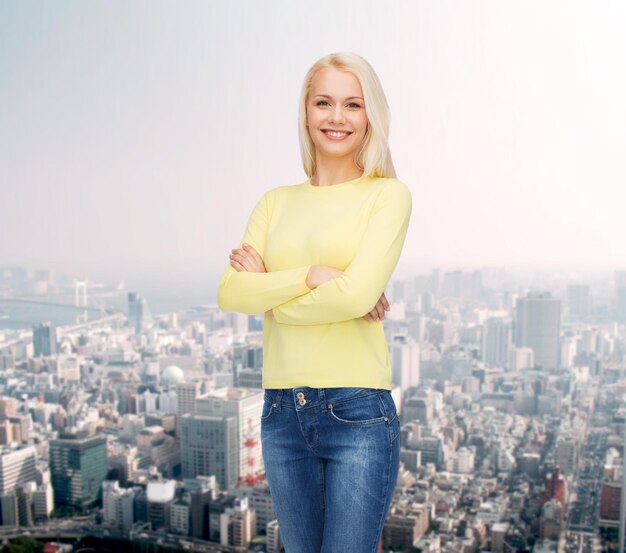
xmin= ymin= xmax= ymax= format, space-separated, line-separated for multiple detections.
xmin=515 ymin=292 xmax=561 ymax=369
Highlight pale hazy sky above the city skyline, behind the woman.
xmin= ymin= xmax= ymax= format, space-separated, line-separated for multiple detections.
xmin=0 ymin=0 xmax=626 ymax=294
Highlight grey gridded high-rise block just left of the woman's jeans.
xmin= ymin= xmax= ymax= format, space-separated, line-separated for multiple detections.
xmin=181 ymin=414 xmax=239 ymax=490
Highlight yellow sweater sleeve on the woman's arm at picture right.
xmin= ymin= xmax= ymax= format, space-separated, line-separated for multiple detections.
xmin=272 ymin=179 xmax=412 ymax=325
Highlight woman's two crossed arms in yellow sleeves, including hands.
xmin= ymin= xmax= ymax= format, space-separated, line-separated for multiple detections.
xmin=218 ymin=179 xmax=412 ymax=325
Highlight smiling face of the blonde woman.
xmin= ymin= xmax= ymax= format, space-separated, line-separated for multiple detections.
xmin=306 ymin=67 xmax=367 ymax=165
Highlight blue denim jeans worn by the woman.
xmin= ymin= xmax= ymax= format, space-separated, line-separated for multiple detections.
xmin=261 ymin=386 xmax=400 ymax=553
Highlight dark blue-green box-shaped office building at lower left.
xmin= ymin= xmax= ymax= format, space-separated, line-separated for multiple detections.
xmin=50 ymin=432 xmax=107 ymax=509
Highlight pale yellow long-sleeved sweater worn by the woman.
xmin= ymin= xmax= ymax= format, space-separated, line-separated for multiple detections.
xmin=218 ymin=177 xmax=412 ymax=390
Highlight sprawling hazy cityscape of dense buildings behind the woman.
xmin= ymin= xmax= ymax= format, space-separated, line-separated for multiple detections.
xmin=0 ymin=267 xmax=626 ymax=553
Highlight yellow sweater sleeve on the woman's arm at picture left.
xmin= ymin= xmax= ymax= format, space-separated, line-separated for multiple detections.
xmin=217 ymin=192 xmax=311 ymax=315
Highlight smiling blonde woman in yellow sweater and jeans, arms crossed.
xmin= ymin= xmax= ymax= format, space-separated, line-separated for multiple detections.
xmin=218 ymin=53 xmax=412 ymax=553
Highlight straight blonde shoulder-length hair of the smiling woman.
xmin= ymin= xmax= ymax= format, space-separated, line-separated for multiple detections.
xmin=298 ymin=52 xmax=396 ymax=178
